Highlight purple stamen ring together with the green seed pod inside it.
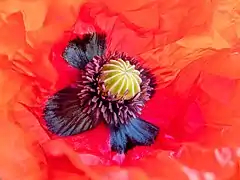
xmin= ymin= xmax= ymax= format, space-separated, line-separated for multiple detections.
xmin=78 ymin=54 xmax=153 ymax=126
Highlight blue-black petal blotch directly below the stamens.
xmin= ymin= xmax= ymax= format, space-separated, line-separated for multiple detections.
xmin=110 ymin=118 xmax=159 ymax=153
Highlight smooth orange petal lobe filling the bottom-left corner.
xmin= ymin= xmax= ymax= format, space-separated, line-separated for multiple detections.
xmin=0 ymin=112 xmax=47 ymax=180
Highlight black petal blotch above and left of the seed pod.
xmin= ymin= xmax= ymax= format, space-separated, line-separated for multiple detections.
xmin=63 ymin=33 xmax=106 ymax=69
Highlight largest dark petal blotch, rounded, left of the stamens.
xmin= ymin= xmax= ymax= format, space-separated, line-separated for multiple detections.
xmin=44 ymin=87 xmax=99 ymax=136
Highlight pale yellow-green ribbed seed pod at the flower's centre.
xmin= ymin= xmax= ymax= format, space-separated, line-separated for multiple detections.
xmin=99 ymin=59 xmax=142 ymax=100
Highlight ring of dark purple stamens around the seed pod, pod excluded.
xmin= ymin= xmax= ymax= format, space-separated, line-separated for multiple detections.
xmin=78 ymin=54 xmax=153 ymax=126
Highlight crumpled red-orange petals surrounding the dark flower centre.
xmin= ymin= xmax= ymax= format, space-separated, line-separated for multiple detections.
xmin=0 ymin=0 xmax=240 ymax=180
